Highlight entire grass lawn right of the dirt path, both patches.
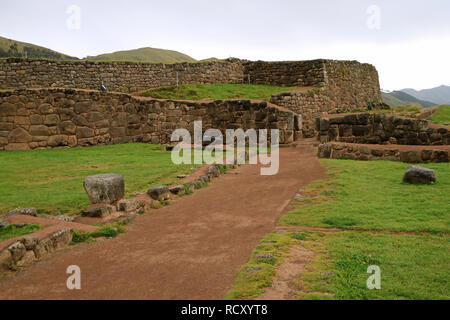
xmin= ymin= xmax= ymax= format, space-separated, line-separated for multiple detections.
xmin=226 ymin=159 xmax=450 ymax=299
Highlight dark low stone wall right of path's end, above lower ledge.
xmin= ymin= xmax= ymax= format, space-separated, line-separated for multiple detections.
xmin=316 ymin=113 xmax=450 ymax=145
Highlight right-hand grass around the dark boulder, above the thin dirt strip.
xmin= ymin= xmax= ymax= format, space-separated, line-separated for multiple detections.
xmin=280 ymin=159 xmax=450 ymax=233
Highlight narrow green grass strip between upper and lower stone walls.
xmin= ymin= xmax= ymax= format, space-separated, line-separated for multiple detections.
xmin=141 ymin=83 xmax=293 ymax=101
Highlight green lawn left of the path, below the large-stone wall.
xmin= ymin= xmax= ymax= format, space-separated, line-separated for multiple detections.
xmin=0 ymin=143 xmax=195 ymax=214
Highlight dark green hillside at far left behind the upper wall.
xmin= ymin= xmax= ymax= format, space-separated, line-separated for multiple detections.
xmin=0 ymin=37 xmax=78 ymax=60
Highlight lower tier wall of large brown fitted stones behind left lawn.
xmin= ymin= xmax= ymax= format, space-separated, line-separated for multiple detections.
xmin=0 ymin=89 xmax=296 ymax=150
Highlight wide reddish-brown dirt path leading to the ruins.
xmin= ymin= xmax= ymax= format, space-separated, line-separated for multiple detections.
xmin=0 ymin=146 xmax=325 ymax=299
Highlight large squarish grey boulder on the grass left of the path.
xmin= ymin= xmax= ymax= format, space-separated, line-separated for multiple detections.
xmin=83 ymin=173 xmax=125 ymax=204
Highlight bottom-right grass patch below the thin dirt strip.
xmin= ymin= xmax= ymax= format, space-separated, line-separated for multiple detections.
xmin=298 ymin=232 xmax=450 ymax=300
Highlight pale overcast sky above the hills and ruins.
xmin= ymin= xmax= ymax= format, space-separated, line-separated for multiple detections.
xmin=0 ymin=0 xmax=450 ymax=90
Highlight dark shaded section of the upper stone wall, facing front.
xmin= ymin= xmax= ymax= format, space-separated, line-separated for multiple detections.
xmin=243 ymin=59 xmax=325 ymax=87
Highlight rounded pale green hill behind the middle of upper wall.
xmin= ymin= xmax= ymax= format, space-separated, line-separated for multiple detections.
xmin=85 ymin=48 xmax=196 ymax=63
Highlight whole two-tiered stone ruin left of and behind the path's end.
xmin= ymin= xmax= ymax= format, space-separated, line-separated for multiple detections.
xmin=0 ymin=58 xmax=382 ymax=150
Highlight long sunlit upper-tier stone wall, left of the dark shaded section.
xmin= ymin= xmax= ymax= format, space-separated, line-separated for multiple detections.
xmin=0 ymin=58 xmax=243 ymax=92
